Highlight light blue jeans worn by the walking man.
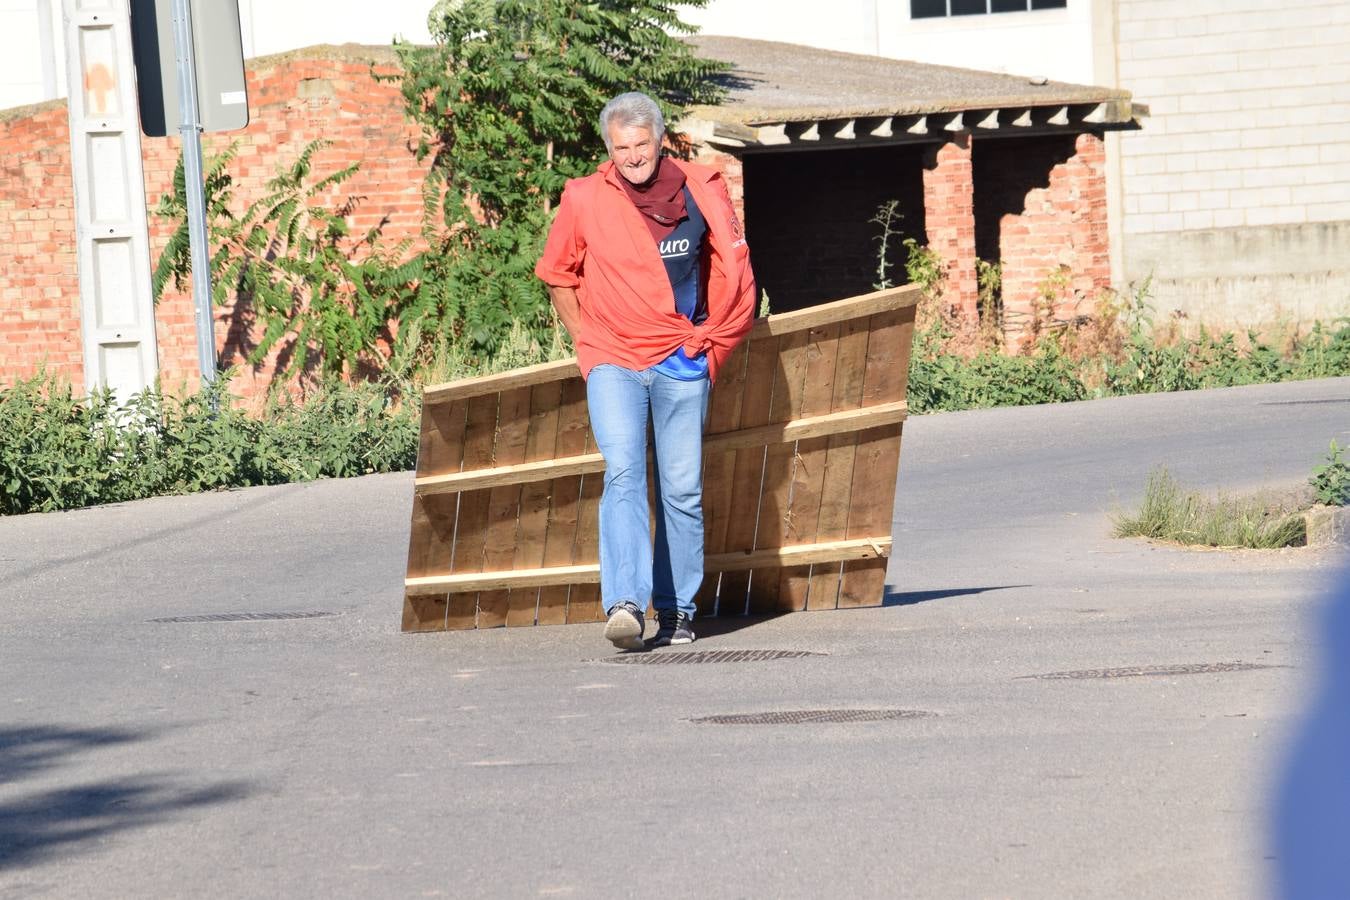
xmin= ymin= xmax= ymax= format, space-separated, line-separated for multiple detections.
xmin=586 ymin=364 xmax=709 ymax=618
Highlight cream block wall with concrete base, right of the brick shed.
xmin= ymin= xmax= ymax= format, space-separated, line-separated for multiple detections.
xmin=1118 ymin=0 xmax=1350 ymax=325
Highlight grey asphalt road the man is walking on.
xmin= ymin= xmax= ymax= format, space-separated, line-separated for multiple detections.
xmin=0 ymin=379 xmax=1350 ymax=899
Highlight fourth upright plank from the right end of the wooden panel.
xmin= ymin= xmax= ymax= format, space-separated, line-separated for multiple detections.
xmin=749 ymin=332 xmax=804 ymax=614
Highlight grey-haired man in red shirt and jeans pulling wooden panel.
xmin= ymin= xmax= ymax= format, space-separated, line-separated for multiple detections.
xmin=535 ymin=92 xmax=755 ymax=649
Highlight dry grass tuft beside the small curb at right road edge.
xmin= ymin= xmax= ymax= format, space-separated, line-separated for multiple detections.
xmin=1114 ymin=468 xmax=1307 ymax=549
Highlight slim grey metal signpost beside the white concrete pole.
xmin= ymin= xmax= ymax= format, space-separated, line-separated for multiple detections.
xmin=166 ymin=0 xmax=216 ymax=387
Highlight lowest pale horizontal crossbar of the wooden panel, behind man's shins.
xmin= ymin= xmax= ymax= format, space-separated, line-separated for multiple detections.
xmin=404 ymin=534 xmax=891 ymax=596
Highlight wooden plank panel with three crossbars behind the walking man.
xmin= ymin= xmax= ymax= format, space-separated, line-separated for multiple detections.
xmin=402 ymin=287 xmax=918 ymax=631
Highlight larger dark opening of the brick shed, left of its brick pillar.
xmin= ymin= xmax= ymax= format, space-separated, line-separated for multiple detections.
xmin=743 ymin=144 xmax=926 ymax=313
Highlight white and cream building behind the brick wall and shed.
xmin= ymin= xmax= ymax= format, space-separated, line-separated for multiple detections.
xmin=0 ymin=0 xmax=1350 ymax=327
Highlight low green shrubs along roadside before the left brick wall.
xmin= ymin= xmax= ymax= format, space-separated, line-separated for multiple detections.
xmin=0 ymin=375 xmax=419 ymax=515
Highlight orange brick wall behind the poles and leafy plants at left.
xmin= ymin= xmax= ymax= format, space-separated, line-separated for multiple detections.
xmin=0 ymin=46 xmax=425 ymax=395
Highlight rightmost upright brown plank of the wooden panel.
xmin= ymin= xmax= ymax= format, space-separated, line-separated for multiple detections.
xmin=840 ymin=310 xmax=914 ymax=609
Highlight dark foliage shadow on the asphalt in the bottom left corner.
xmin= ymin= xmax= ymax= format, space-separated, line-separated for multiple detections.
xmin=0 ymin=726 xmax=250 ymax=872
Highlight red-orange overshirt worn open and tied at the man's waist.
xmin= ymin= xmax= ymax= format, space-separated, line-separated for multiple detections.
xmin=535 ymin=158 xmax=755 ymax=379
